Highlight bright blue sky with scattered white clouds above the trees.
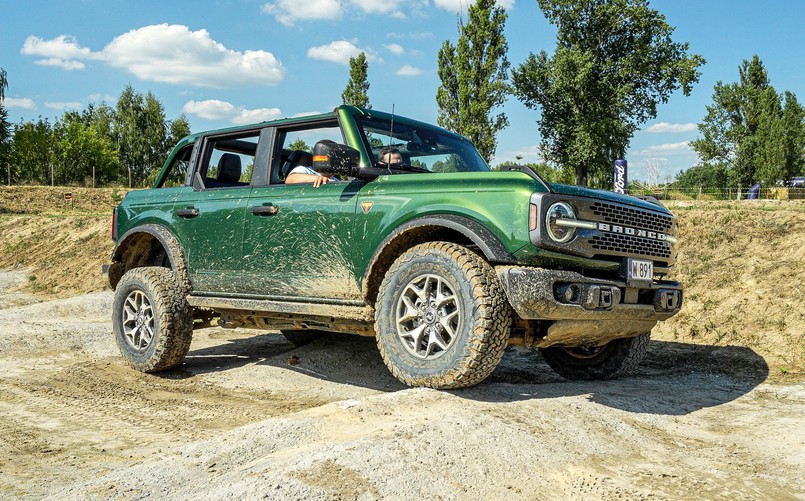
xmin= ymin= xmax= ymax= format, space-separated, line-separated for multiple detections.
xmin=0 ymin=0 xmax=805 ymax=181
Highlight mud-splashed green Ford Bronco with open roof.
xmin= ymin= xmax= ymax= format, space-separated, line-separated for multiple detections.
xmin=108 ymin=106 xmax=682 ymax=388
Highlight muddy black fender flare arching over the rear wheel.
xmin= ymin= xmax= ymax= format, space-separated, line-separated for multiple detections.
xmin=109 ymin=224 xmax=191 ymax=293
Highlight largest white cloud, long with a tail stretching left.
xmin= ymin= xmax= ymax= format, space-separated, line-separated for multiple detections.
xmin=21 ymin=24 xmax=285 ymax=87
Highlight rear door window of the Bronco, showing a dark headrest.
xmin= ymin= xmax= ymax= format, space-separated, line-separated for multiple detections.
xmin=199 ymin=130 xmax=260 ymax=188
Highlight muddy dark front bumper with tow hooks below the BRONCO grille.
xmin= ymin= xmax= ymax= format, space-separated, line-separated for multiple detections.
xmin=496 ymin=266 xmax=682 ymax=348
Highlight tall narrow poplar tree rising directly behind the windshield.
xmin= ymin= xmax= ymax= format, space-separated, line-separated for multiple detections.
xmin=436 ymin=0 xmax=510 ymax=161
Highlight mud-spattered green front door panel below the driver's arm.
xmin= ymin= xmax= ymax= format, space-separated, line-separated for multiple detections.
xmin=243 ymin=180 xmax=362 ymax=301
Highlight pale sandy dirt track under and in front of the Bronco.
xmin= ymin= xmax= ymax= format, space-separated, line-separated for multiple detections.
xmin=0 ymin=274 xmax=805 ymax=499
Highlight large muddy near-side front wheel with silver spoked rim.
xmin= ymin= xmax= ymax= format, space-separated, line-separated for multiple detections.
xmin=375 ymin=242 xmax=512 ymax=388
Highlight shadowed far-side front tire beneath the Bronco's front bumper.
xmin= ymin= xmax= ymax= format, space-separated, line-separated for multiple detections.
xmin=540 ymin=332 xmax=651 ymax=381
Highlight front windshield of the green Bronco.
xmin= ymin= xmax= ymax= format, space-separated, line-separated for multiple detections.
xmin=357 ymin=117 xmax=489 ymax=172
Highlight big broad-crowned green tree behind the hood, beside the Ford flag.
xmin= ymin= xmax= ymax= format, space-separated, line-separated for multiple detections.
xmin=512 ymin=0 xmax=705 ymax=187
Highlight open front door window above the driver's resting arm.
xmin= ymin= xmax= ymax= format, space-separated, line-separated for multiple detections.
xmin=271 ymin=122 xmax=344 ymax=183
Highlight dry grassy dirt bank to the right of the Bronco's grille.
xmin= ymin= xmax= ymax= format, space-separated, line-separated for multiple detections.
xmin=652 ymin=200 xmax=805 ymax=379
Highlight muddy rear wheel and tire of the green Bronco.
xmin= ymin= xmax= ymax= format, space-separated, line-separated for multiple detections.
xmin=112 ymin=267 xmax=193 ymax=372
